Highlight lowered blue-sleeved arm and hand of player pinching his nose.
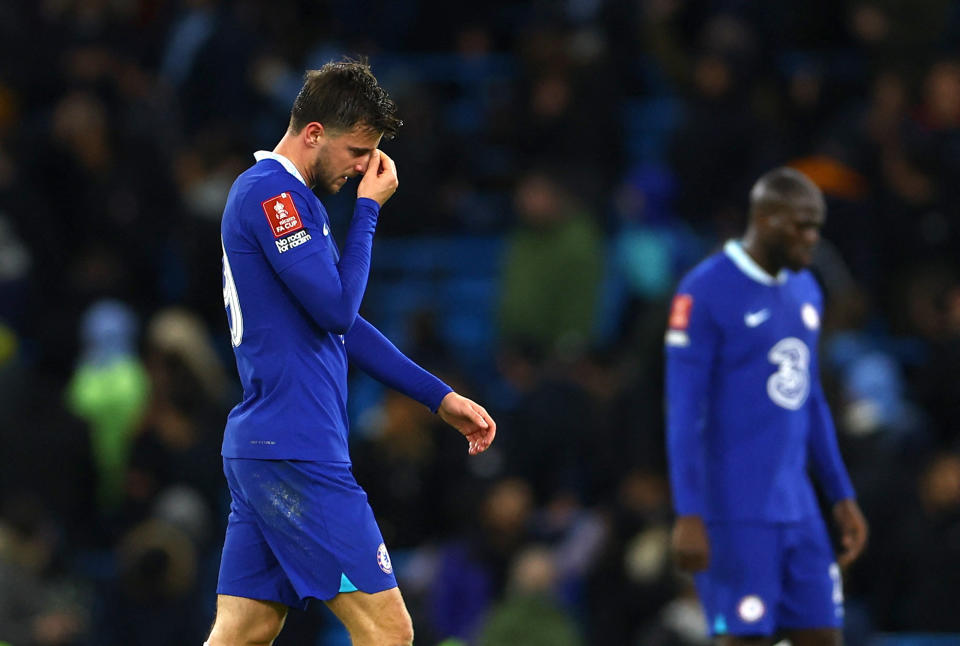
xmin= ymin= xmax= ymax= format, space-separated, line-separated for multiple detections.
xmin=343 ymin=316 xmax=497 ymax=455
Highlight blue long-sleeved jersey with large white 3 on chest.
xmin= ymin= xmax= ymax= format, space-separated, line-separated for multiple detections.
xmin=665 ymin=241 xmax=853 ymax=522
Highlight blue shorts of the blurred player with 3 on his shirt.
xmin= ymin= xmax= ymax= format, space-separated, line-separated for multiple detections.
xmin=696 ymin=516 xmax=843 ymax=636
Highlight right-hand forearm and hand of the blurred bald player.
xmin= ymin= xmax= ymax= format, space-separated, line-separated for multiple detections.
xmin=809 ymin=371 xmax=868 ymax=567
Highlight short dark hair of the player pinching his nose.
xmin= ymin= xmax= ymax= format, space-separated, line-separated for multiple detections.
xmin=289 ymin=59 xmax=403 ymax=139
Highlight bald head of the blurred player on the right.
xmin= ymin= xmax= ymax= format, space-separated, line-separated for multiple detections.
xmin=744 ymin=167 xmax=826 ymax=273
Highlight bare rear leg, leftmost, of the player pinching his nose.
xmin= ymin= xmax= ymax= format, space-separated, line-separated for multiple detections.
xmin=208 ymin=594 xmax=287 ymax=646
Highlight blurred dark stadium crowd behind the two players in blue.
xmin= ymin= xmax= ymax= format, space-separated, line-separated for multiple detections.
xmin=0 ymin=0 xmax=960 ymax=646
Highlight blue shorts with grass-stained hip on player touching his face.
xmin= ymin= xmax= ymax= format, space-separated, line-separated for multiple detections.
xmin=217 ymin=458 xmax=397 ymax=608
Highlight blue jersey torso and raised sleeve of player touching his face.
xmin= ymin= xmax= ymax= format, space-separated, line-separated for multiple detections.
xmin=221 ymin=152 xmax=379 ymax=462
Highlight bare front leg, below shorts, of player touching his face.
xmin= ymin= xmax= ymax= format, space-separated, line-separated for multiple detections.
xmin=325 ymin=588 xmax=413 ymax=645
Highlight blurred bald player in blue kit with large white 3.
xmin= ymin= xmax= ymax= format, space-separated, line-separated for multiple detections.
xmin=666 ymin=168 xmax=867 ymax=646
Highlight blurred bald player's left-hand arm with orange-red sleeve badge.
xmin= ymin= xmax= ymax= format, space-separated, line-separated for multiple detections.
xmin=666 ymin=292 xmax=719 ymax=571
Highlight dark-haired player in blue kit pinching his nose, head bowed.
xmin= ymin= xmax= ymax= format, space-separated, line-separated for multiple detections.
xmin=207 ymin=61 xmax=496 ymax=646
